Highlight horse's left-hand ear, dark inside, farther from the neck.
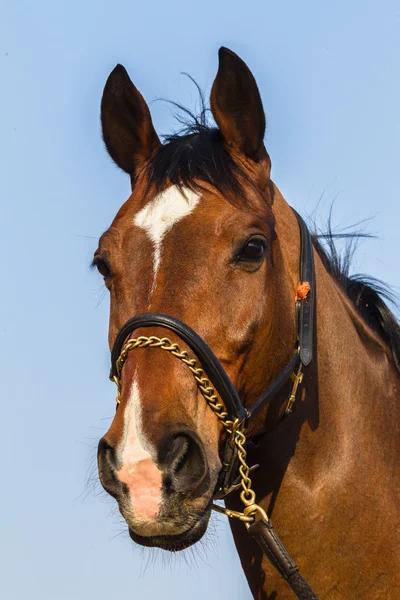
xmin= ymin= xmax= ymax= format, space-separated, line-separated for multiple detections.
xmin=101 ymin=65 xmax=160 ymax=181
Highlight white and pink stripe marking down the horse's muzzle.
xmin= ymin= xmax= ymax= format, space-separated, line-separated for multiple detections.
xmin=117 ymin=379 xmax=162 ymax=522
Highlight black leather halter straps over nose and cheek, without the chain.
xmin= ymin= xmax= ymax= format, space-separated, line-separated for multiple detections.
xmin=110 ymin=209 xmax=315 ymax=425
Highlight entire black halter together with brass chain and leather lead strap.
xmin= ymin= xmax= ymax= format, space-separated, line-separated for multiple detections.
xmin=110 ymin=209 xmax=318 ymax=600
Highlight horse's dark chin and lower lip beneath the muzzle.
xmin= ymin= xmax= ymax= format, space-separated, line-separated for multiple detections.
xmin=129 ymin=510 xmax=211 ymax=552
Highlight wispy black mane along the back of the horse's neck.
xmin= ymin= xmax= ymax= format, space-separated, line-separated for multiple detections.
xmin=312 ymin=214 xmax=400 ymax=372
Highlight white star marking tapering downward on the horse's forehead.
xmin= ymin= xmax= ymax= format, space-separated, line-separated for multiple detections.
xmin=133 ymin=185 xmax=200 ymax=288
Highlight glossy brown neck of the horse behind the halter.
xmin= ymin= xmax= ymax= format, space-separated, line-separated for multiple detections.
xmin=227 ymin=189 xmax=400 ymax=598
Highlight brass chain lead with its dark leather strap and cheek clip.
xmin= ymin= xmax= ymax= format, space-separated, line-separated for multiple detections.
xmin=113 ymin=336 xmax=318 ymax=600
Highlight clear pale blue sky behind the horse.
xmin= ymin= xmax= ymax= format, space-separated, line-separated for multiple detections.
xmin=0 ymin=0 xmax=400 ymax=600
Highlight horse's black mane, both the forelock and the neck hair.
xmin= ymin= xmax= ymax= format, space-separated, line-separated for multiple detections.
xmin=145 ymin=86 xmax=400 ymax=372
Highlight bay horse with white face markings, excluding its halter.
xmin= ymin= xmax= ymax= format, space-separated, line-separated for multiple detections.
xmin=93 ymin=48 xmax=400 ymax=600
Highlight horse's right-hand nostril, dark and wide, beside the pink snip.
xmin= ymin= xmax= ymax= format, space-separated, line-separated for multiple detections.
xmin=160 ymin=432 xmax=208 ymax=495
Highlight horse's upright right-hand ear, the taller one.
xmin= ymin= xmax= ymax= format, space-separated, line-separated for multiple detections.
xmin=211 ymin=47 xmax=266 ymax=162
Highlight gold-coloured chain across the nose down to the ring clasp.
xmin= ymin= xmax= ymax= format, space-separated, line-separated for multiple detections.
xmin=113 ymin=335 xmax=268 ymax=527
